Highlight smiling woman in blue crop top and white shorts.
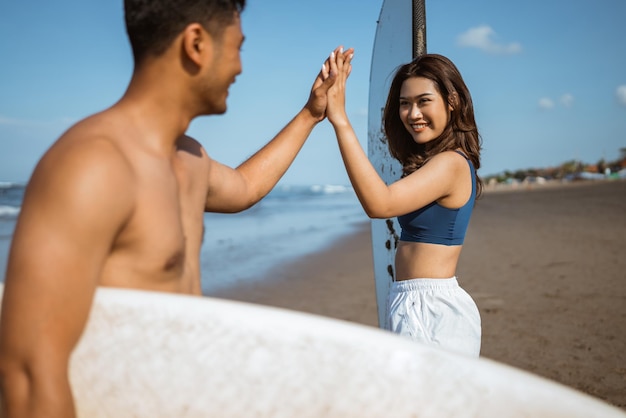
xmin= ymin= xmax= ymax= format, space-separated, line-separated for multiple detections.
xmin=327 ymin=43 xmax=482 ymax=356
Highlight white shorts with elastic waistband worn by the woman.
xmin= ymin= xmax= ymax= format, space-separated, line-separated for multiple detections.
xmin=385 ymin=277 xmax=481 ymax=357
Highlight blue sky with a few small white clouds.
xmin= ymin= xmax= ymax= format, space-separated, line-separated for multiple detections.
xmin=0 ymin=0 xmax=626 ymax=184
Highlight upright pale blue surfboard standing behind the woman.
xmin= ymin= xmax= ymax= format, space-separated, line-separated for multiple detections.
xmin=367 ymin=0 xmax=414 ymax=327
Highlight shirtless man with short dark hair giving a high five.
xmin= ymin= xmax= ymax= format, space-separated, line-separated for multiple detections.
xmin=0 ymin=0 xmax=346 ymax=418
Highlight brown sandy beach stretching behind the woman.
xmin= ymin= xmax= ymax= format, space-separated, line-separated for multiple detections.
xmin=211 ymin=181 xmax=626 ymax=409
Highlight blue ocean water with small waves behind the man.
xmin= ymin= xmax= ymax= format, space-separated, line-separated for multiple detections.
xmin=0 ymin=182 xmax=367 ymax=294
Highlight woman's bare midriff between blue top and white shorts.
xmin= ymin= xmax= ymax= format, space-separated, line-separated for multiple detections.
xmin=395 ymin=241 xmax=462 ymax=281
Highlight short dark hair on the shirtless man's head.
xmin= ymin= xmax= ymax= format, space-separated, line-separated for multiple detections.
xmin=124 ymin=0 xmax=246 ymax=64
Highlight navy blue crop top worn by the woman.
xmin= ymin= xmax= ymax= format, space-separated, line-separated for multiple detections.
xmin=398 ymin=151 xmax=476 ymax=245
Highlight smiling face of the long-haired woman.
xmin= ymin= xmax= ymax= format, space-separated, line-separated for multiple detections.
xmin=400 ymin=77 xmax=452 ymax=144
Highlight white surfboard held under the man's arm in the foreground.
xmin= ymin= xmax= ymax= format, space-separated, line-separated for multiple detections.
xmin=0 ymin=285 xmax=626 ymax=418
